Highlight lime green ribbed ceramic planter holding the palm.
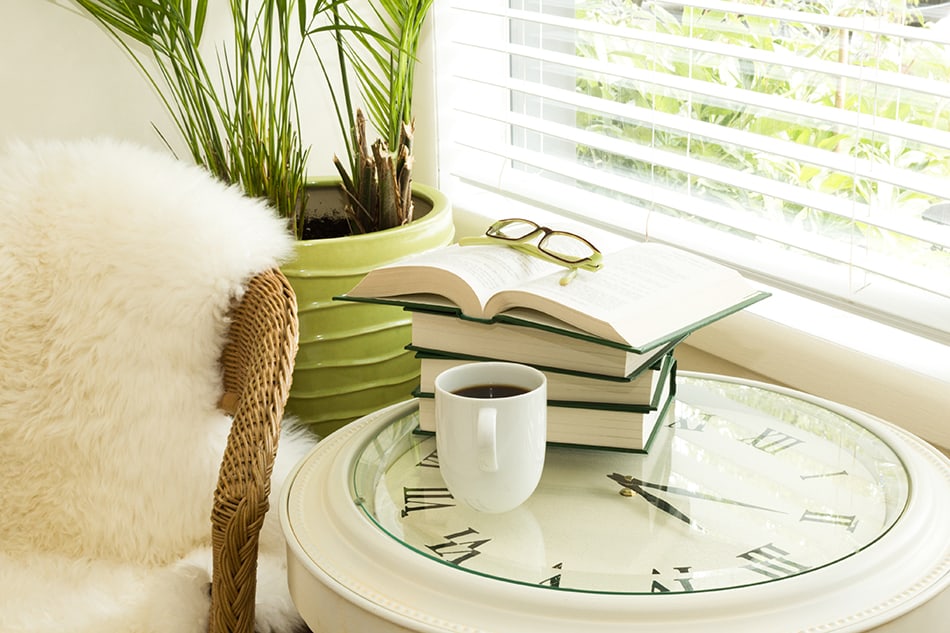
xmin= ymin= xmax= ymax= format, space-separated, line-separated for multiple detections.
xmin=282 ymin=180 xmax=455 ymax=436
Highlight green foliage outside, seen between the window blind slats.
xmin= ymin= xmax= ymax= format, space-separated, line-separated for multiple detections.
xmin=576 ymin=0 xmax=950 ymax=266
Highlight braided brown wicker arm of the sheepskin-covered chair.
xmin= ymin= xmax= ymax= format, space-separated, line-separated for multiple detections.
xmin=209 ymin=269 xmax=297 ymax=633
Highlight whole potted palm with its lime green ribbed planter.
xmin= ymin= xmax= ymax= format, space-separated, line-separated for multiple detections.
xmin=75 ymin=0 xmax=453 ymax=434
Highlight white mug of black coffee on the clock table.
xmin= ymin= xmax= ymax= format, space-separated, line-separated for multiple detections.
xmin=435 ymin=362 xmax=547 ymax=512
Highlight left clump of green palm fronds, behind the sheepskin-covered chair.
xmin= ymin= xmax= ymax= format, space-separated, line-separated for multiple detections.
xmin=76 ymin=0 xmax=326 ymax=237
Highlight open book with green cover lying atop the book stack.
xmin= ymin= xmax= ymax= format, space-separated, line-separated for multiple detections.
xmin=338 ymin=243 xmax=768 ymax=353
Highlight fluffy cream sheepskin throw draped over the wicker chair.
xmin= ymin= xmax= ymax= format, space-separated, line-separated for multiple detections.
xmin=0 ymin=140 xmax=311 ymax=633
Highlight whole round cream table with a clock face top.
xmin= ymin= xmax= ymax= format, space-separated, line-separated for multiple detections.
xmin=280 ymin=372 xmax=950 ymax=633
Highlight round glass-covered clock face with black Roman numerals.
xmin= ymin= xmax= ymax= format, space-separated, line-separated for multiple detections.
xmin=352 ymin=379 xmax=908 ymax=594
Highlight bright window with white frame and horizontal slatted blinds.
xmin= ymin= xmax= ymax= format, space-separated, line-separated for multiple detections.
xmin=436 ymin=0 xmax=950 ymax=343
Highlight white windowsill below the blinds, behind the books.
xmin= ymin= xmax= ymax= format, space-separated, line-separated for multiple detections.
xmin=453 ymin=194 xmax=950 ymax=447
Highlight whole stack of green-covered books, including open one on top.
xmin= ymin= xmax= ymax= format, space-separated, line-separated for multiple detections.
xmin=339 ymin=239 xmax=768 ymax=451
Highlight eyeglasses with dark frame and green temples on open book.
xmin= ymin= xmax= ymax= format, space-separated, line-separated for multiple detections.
xmin=459 ymin=218 xmax=603 ymax=286
